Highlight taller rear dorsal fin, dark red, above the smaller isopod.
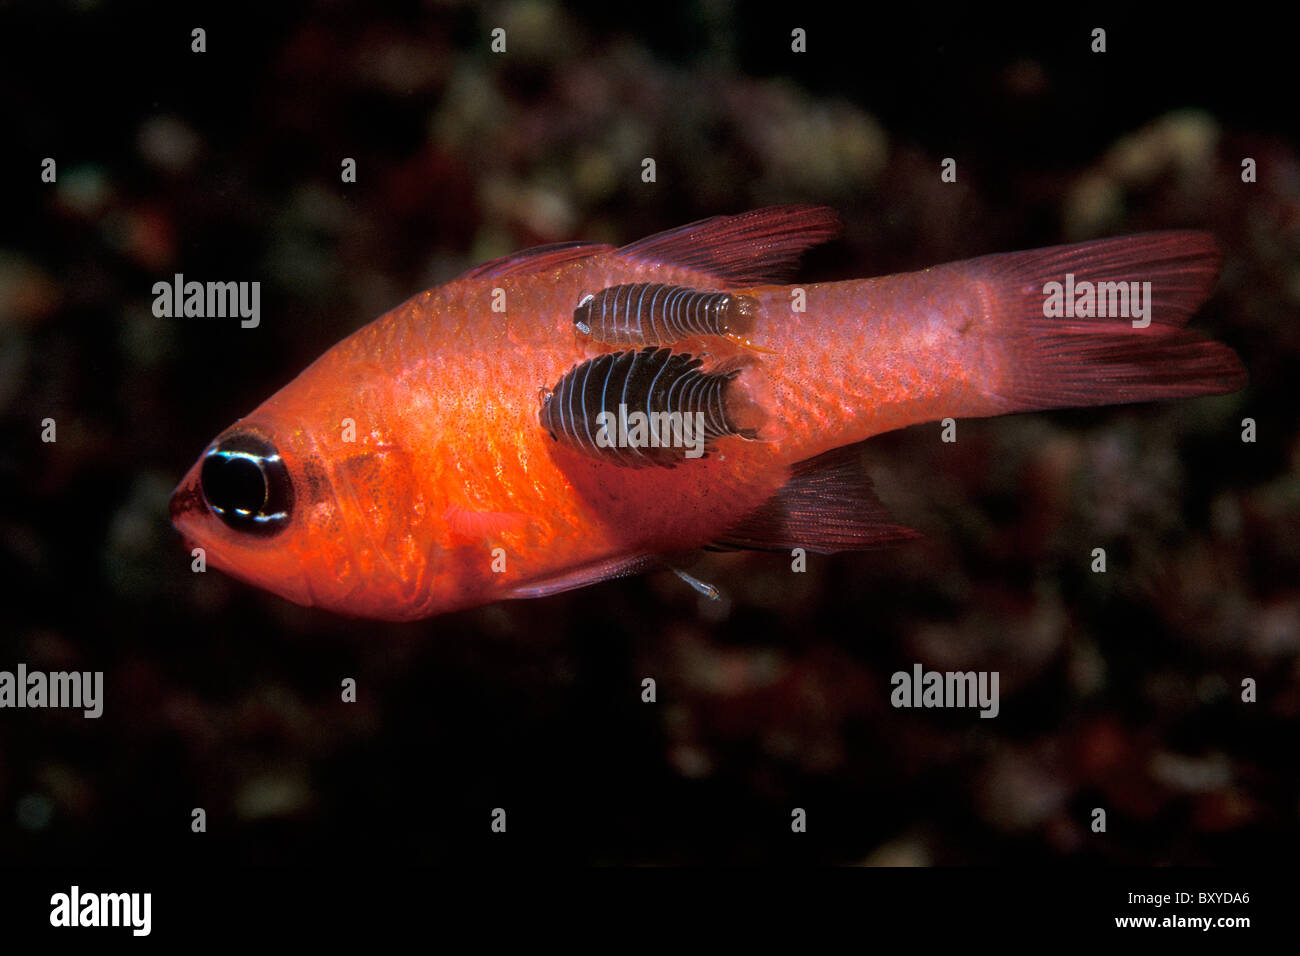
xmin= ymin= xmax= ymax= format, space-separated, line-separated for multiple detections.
xmin=618 ymin=204 xmax=840 ymax=284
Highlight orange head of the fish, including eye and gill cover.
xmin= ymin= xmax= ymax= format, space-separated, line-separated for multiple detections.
xmin=170 ymin=406 xmax=437 ymax=619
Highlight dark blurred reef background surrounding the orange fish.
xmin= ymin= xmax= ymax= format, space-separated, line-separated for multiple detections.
xmin=0 ymin=0 xmax=1300 ymax=865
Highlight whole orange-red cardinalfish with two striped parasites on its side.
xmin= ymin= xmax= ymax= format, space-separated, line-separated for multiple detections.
xmin=172 ymin=206 xmax=1245 ymax=620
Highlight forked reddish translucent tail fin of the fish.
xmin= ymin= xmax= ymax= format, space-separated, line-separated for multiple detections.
xmin=963 ymin=232 xmax=1247 ymax=411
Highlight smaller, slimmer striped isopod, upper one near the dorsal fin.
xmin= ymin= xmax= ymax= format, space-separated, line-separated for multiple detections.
xmin=573 ymin=282 xmax=757 ymax=345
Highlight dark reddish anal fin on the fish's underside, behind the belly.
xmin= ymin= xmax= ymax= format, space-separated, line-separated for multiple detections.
xmin=710 ymin=445 xmax=919 ymax=554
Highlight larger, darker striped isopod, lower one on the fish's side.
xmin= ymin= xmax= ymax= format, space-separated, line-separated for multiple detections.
xmin=538 ymin=346 xmax=754 ymax=468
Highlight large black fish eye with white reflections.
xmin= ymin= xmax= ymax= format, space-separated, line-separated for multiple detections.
xmin=199 ymin=432 xmax=294 ymax=535
